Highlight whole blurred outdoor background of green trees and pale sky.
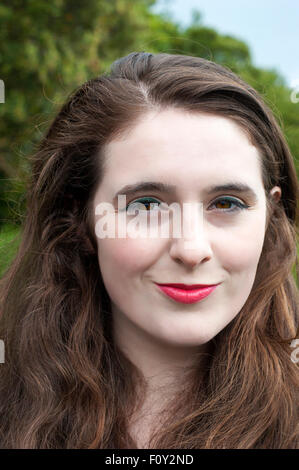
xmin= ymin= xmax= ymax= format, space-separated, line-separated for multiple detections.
xmin=0 ymin=0 xmax=299 ymax=277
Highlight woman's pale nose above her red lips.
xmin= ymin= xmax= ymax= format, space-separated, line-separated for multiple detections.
xmin=169 ymin=203 xmax=213 ymax=267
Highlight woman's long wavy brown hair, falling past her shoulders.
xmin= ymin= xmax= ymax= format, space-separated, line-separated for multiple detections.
xmin=0 ymin=52 xmax=299 ymax=449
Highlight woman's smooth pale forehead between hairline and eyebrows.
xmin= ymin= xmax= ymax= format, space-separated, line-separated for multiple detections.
xmin=104 ymin=109 xmax=261 ymax=189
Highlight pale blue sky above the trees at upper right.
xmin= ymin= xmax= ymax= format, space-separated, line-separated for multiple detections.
xmin=152 ymin=0 xmax=299 ymax=87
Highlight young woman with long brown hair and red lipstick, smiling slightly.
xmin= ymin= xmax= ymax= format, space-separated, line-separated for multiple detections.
xmin=0 ymin=52 xmax=298 ymax=449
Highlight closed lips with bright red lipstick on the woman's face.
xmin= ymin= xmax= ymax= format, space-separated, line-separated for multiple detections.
xmin=157 ymin=284 xmax=218 ymax=304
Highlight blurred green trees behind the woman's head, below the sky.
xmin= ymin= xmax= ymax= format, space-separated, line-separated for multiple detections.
xmin=0 ymin=0 xmax=299 ymax=229
